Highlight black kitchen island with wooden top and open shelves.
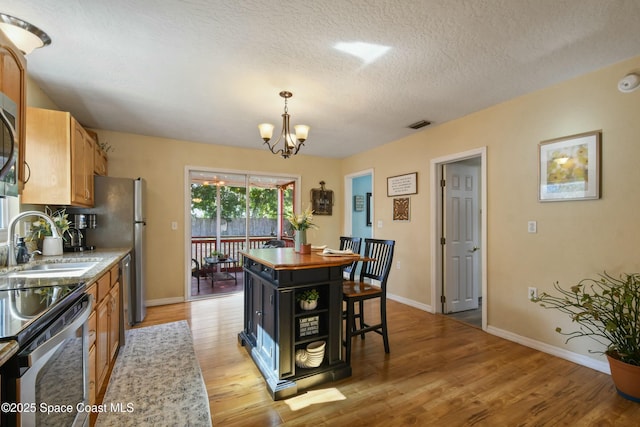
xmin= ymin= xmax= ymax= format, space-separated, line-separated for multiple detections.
xmin=238 ymin=248 xmax=354 ymax=400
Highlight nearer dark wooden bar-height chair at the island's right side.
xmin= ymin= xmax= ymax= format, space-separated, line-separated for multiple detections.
xmin=342 ymin=239 xmax=395 ymax=365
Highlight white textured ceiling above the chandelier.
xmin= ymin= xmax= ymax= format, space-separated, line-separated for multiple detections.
xmin=0 ymin=0 xmax=640 ymax=158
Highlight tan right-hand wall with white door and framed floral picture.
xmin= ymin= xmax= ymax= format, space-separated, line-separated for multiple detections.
xmin=342 ymin=57 xmax=640 ymax=362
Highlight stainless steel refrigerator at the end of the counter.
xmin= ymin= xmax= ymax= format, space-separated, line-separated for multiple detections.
xmin=87 ymin=176 xmax=147 ymax=325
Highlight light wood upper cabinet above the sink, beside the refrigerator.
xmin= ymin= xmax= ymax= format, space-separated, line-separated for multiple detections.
xmin=22 ymin=107 xmax=95 ymax=207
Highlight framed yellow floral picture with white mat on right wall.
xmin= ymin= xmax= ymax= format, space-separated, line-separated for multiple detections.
xmin=538 ymin=131 xmax=601 ymax=202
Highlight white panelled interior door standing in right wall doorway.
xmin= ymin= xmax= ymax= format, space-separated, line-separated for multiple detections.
xmin=443 ymin=163 xmax=480 ymax=313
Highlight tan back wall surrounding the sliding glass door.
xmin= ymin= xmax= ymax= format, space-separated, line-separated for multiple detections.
xmin=91 ymin=131 xmax=342 ymax=300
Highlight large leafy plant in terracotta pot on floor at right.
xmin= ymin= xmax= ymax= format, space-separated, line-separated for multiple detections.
xmin=531 ymin=272 xmax=640 ymax=402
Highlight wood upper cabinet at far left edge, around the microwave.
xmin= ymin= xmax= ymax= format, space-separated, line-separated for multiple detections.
xmin=0 ymin=31 xmax=27 ymax=195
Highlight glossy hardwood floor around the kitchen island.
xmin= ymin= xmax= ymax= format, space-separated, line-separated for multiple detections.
xmin=140 ymin=294 xmax=640 ymax=426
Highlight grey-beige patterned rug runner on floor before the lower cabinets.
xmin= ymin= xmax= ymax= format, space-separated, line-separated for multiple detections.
xmin=96 ymin=320 xmax=211 ymax=427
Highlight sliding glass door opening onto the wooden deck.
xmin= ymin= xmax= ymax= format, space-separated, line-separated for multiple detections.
xmin=187 ymin=170 xmax=298 ymax=299
